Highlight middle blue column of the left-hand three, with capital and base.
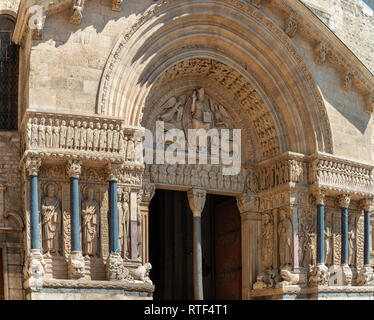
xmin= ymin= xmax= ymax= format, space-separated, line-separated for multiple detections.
xmin=66 ymin=160 xmax=85 ymax=279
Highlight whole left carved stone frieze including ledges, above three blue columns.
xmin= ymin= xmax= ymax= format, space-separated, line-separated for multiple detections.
xmin=20 ymin=111 xmax=136 ymax=163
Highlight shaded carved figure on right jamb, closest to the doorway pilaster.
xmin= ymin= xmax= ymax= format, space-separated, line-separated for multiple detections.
xmin=261 ymin=212 xmax=274 ymax=270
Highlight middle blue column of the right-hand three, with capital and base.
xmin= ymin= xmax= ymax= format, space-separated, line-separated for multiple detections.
xmin=338 ymin=194 xmax=352 ymax=285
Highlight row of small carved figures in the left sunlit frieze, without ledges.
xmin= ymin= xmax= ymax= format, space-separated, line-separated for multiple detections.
xmin=25 ymin=114 xmax=140 ymax=162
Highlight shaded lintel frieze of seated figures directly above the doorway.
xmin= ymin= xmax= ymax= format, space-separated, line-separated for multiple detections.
xmin=149 ymin=164 xmax=248 ymax=193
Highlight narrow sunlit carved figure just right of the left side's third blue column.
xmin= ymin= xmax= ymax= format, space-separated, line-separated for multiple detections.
xmin=118 ymin=188 xmax=130 ymax=260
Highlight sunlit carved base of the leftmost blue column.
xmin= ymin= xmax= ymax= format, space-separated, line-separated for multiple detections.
xmin=24 ymin=249 xmax=45 ymax=290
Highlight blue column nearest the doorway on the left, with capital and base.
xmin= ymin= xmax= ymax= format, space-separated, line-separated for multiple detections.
xmin=106 ymin=164 xmax=128 ymax=280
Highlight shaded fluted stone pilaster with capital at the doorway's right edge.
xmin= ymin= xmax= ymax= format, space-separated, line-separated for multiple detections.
xmin=236 ymin=194 xmax=261 ymax=300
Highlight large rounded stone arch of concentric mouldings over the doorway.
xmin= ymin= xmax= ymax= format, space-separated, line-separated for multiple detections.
xmin=97 ymin=0 xmax=333 ymax=161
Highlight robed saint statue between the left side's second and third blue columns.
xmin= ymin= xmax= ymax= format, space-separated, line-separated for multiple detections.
xmin=82 ymin=187 xmax=99 ymax=256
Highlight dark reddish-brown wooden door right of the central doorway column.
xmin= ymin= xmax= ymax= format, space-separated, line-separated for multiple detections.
xmin=215 ymin=199 xmax=242 ymax=300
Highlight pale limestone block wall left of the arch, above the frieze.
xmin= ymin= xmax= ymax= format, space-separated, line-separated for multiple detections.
xmin=29 ymin=0 xmax=151 ymax=113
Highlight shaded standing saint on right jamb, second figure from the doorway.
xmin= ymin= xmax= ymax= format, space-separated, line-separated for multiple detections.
xmin=278 ymin=209 xmax=292 ymax=268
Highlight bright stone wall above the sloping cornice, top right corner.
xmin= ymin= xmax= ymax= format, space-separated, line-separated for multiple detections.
xmin=302 ymin=0 xmax=374 ymax=73
